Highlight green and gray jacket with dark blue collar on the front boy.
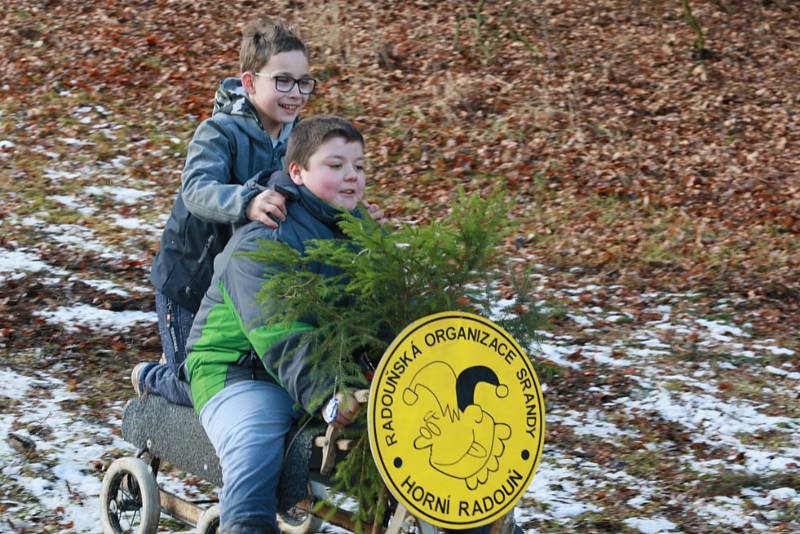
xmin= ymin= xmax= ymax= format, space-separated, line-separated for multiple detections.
xmin=186 ymin=182 xmax=355 ymax=413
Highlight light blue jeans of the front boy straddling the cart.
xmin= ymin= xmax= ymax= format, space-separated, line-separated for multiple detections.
xmin=200 ymin=380 xmax=302 ymax=532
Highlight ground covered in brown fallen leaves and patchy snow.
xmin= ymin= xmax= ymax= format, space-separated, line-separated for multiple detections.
xmin=0 ymin=0 xmax=800 ymax=532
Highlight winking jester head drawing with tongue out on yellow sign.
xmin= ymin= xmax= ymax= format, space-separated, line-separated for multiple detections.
xmin=403 ymin=361 xmax=511 ymax=490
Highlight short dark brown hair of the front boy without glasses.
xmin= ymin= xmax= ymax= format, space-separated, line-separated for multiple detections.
xmin=285 ymin=115 xmax=364 ymax=169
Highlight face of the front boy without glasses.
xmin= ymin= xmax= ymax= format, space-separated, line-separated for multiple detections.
xmin=289 ymin=137 xmax=366 ymax=211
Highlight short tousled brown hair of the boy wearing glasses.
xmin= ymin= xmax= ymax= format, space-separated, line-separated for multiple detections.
xmin=239 ymin=17 xmax=308 ymax=72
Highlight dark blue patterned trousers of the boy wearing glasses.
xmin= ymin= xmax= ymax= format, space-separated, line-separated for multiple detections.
xmin=143 ymin=291 xmax=194 ymax=406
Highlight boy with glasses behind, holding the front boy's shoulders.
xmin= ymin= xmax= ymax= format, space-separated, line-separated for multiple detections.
xmin=136 ymin=19 xmax=316 ymax=405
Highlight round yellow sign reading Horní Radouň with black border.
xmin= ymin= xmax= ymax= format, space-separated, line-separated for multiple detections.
xmin=367 ymin=312 xmax=544 ymax=529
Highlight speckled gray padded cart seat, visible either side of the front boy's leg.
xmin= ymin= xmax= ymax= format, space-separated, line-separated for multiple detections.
xmin=122 ymin=395 xmax=320 ymax=511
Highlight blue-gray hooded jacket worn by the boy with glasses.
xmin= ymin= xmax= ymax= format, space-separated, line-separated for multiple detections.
xmin=150 ymin=78 xmax=297 ymax=313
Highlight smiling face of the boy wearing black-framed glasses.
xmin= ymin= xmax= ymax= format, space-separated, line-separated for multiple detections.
xmin=241 ymin=50 xmax=310 ymax=137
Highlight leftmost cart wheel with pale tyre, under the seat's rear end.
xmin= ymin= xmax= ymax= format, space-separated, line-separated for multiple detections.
xmin=100 ymin=457 xmax=161 ymax=534
